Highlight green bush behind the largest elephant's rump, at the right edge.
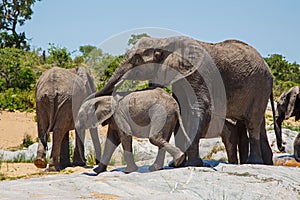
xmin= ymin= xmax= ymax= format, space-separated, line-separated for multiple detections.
xmin=265 ymin=54 xmax=300 ymax=97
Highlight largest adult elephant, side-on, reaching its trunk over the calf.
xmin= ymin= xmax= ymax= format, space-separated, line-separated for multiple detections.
xmin=95 ymin=37 xmax=281 ymax=166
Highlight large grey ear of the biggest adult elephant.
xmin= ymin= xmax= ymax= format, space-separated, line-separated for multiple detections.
xmin=155 ymin=37 xmax=210 ymax=84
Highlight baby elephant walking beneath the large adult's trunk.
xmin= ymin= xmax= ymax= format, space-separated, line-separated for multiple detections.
xmin=76 ymin=88 xmax=190 ymax=174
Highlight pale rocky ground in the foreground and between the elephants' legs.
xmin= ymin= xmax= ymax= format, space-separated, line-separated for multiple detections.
xmin=0 ymin=111 xmax=300 ymax=199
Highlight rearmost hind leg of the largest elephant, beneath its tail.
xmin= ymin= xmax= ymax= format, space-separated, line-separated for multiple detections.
xmin=260 ymin=118 xmax=273 ymax=165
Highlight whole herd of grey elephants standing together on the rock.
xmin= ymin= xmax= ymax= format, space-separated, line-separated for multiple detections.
xmin=34 ymin=36 xmax=300 ymax=173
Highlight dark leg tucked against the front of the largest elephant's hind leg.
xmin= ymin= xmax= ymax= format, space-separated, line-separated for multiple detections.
xmin=236 ymin=121 xmax=249 ymax=164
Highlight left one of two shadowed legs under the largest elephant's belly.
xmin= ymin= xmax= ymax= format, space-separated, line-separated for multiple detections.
xmin=221 ymin=121 xmax=238 ymax=164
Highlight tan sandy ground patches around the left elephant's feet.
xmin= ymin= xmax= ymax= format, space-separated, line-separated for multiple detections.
xmin=0 ymin=111 xmax=100 ymax=179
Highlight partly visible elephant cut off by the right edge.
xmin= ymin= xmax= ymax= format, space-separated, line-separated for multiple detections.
xmin=275 ymin=86 xmax=300 ymax=161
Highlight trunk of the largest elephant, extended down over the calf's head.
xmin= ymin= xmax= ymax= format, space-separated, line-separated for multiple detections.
xmin=95 ymin=63 xmax=133 ymax=97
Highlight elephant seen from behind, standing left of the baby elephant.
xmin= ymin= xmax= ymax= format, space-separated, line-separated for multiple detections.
xmin=34 ymin=67 xmax=100 ymax=171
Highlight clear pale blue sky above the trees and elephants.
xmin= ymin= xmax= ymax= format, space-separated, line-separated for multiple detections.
xmin=19 ymin=0 xmax=300 ymax=63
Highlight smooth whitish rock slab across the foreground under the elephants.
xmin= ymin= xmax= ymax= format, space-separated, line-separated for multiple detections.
xmin=0 ymin=164 xmax=300 ymax=200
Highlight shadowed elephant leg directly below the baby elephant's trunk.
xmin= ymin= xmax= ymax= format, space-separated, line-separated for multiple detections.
xmin=72 ymin=129 xmax=86 ymax=166
